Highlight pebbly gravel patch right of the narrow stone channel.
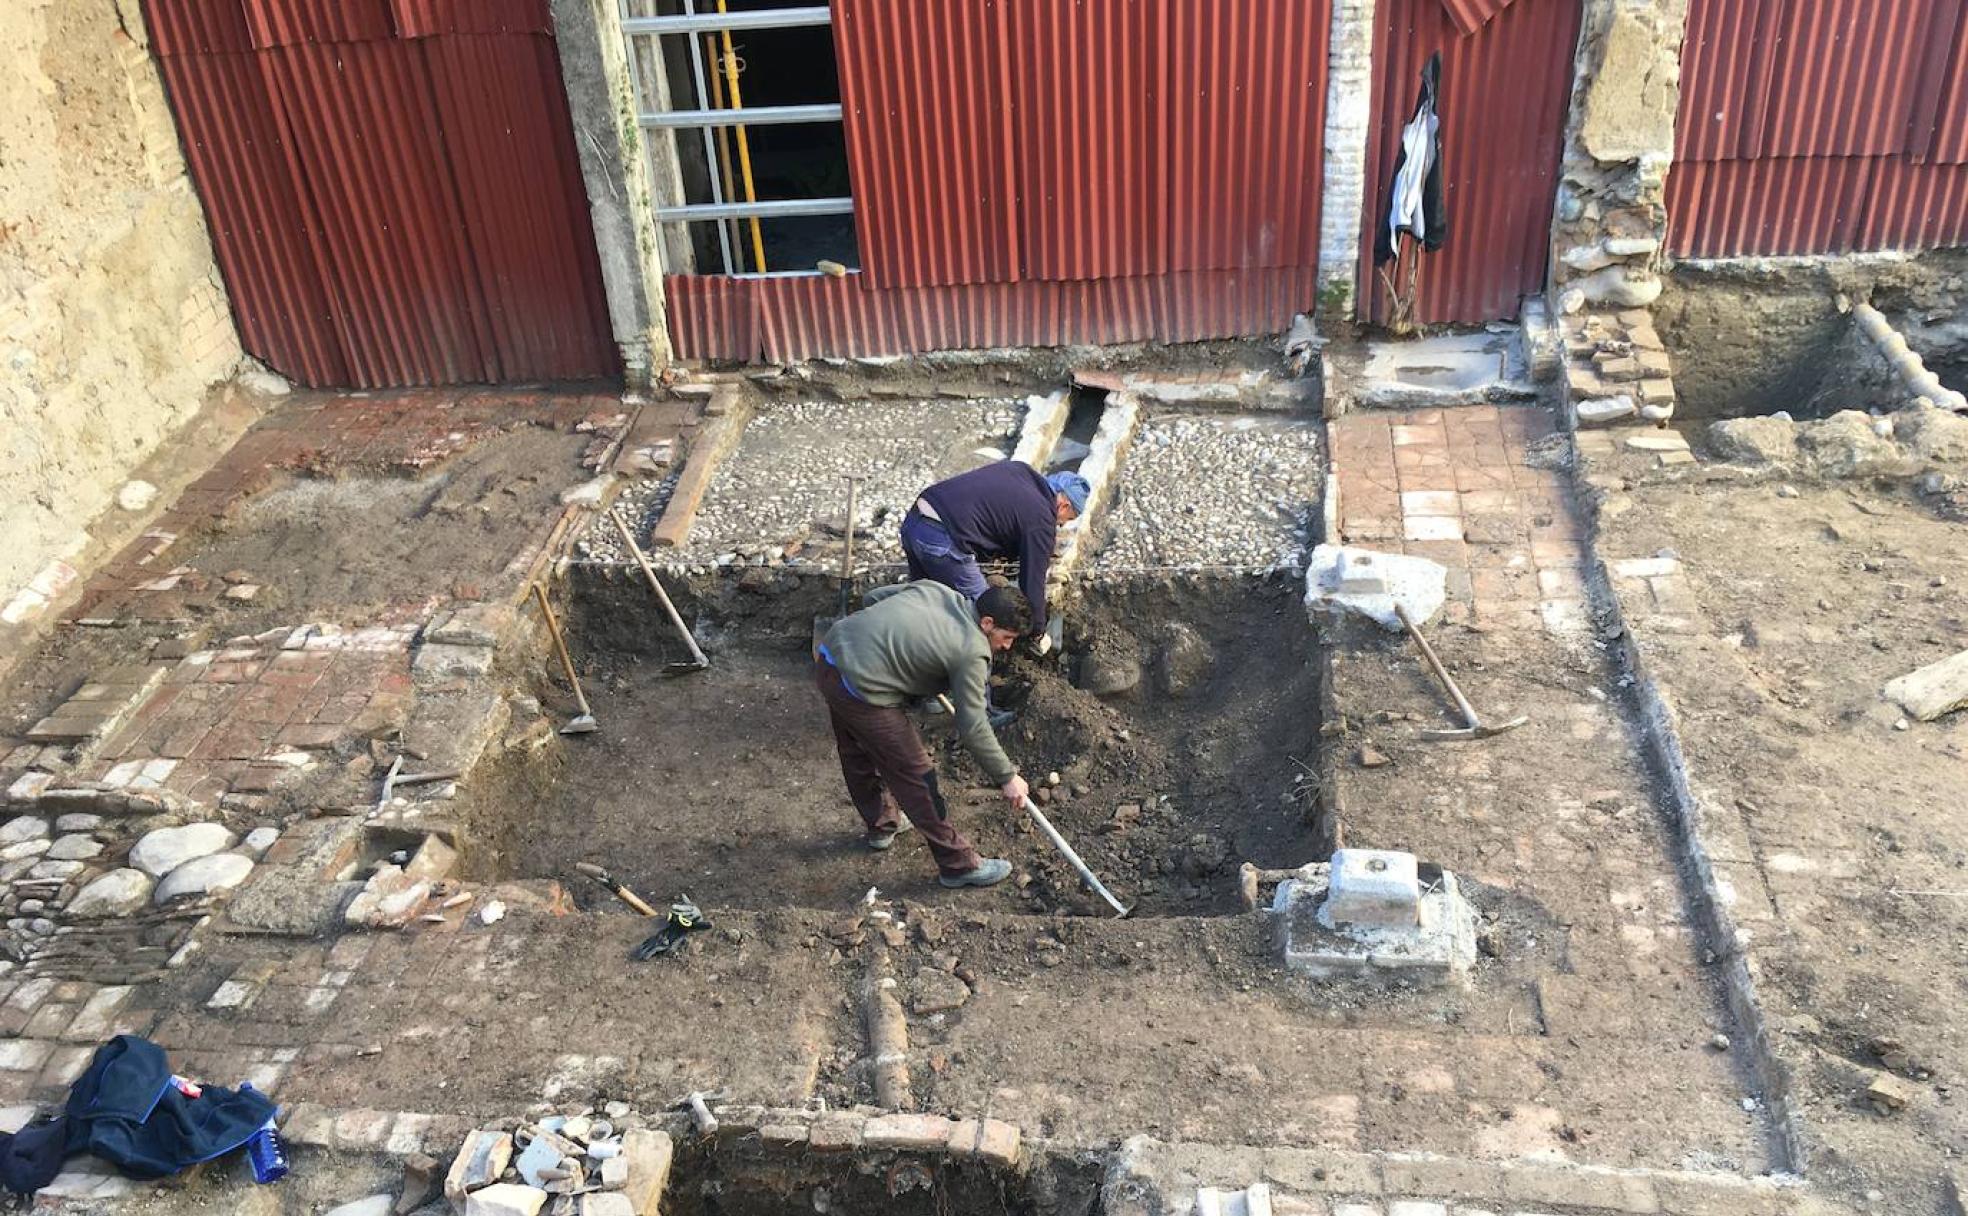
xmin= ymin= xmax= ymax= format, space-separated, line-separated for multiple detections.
xmin=1090 ymin=413 xmax=1326 ymax=575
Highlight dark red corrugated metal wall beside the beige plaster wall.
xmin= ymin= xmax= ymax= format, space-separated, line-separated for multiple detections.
xmin=146 ymin=0 xmax=620 ymax=388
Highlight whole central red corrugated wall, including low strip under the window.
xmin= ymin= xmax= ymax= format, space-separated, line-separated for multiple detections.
xmin=667 ymin=0 xmax=1330 ymax=360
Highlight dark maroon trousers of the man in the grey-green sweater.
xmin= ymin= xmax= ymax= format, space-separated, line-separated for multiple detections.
xmin=813 ymin=659 xmax=978 ymax=874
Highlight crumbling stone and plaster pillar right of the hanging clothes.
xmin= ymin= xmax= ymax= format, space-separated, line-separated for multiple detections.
xmin=1551 ymin=0 xmax=1689 ymax=313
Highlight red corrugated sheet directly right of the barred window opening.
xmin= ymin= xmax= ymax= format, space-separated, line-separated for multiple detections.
xmin=832 ymin=0 xmax=1021 ymax=287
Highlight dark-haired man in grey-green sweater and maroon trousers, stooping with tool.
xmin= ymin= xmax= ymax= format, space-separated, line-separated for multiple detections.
xmin=813 ymin=580 xmax=1031 ymax=887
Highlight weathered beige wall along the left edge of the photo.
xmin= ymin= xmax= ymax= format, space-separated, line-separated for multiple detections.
xmin=0 ymin=0 xmax=240 ymax=624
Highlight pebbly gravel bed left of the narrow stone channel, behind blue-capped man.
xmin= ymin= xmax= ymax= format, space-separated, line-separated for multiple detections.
xmin=577 ymin=401 xmax=1025 ymax=573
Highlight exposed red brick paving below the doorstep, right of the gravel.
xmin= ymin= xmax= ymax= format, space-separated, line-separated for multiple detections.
xmin=1332 ymin=405 xmax=1584 ymax=636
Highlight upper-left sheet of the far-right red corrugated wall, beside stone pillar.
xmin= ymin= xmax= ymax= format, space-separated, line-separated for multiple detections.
xmin=1675 ymin=0 xmax=1779 ymax=161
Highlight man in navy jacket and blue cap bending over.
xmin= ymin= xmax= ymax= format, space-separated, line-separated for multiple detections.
xmin=901 ymin=460 xmax=1090 ymax=634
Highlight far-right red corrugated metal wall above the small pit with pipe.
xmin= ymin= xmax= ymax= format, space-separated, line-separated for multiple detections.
xmin=1667 ymin=0 xmax=1968 ymax=258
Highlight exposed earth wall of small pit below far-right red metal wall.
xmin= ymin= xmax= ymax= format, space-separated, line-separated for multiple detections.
xmin=1653 ymin=250 xmax=1968 ymax=419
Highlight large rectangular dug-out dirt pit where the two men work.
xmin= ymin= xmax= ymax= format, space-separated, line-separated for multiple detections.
xmin=472 ymin=567 xmax=1322 ymax=917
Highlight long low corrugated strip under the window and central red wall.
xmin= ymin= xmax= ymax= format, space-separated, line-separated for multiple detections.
xmin=665 ymin=268 xmax=1319 ymax=362
